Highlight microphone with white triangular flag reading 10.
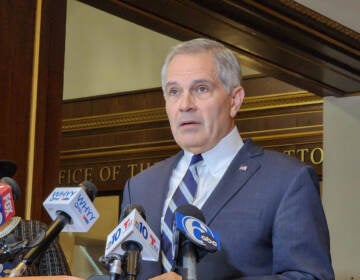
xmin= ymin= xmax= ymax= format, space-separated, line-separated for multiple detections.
xmin=105 ymin=204 xmax=160 ymax=279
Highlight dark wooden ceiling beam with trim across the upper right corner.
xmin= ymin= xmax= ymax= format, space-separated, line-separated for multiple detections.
xmin=80 ymin=0 xmax=360 ymax=96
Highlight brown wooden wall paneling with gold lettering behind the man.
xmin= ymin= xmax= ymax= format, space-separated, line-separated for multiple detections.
xmin=58 ymin=77 xmax=322 ymax=196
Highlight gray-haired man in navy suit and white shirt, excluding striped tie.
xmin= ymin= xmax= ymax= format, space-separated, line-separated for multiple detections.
xmin=122 ymin=39 xmax=334 ymax=280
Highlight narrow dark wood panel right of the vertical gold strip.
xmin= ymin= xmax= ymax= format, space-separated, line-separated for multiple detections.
xmin=35 ymin=0 xmax=66 ymax=221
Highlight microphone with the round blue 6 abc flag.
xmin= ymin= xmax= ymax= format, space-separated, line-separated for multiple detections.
xmin=172 ymin=204 xmax=220 ymax=280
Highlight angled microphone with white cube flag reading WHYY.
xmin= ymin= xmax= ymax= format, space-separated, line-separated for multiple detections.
xmin=9 ymin=181 xmax=99 ymax=277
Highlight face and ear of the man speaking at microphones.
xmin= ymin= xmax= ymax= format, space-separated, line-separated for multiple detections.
xmin=165 ymin=53 xmax=244 ymax=154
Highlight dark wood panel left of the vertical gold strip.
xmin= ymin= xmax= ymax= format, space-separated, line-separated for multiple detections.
xmin=0 ymin=1 xmax=36 ymax=216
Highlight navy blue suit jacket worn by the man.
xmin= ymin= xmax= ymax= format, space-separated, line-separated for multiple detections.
xmin=122 ymin=140 xmax=334 ymax=280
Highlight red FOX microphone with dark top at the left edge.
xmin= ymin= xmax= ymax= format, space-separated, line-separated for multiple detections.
xmin=0 ymin=177 xmax=21 ymax=226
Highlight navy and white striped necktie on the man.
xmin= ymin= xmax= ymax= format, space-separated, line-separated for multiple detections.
xmin=161 ymin=154 xmax=203 ymax=272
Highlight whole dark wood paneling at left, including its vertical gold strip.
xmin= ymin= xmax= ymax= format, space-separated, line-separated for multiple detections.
xmin=0 ymin=0 xmax=66 ymax=220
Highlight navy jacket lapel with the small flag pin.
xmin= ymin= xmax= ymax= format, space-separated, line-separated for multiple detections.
xmin=202 ymin=140 xmax=263 ymax=224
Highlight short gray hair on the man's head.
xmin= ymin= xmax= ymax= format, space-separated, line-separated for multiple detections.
xmin=161 ymin=38 xmax=241 ymax=93
